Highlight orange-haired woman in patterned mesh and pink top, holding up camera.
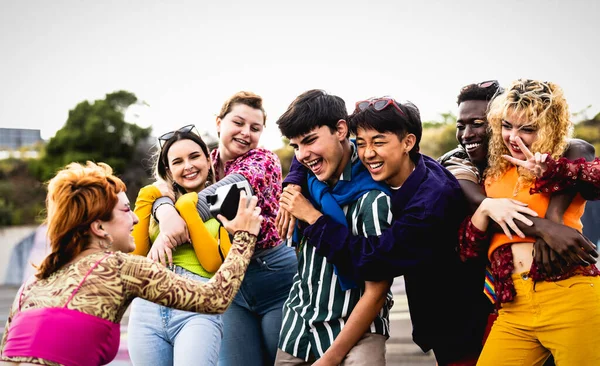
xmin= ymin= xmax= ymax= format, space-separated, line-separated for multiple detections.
xmin=0 ymin=162 xmax=262 ymax=366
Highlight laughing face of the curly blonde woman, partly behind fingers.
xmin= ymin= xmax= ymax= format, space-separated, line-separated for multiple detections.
xmin=502 ymin=112 xmax=537 ymax=160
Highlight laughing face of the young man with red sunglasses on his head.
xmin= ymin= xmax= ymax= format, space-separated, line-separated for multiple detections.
xmin=356 ymin=128 xmax=416 ymax=187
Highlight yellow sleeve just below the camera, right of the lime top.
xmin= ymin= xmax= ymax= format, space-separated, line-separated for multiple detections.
xmin=175 ymin=192 xmax=226 ymax=272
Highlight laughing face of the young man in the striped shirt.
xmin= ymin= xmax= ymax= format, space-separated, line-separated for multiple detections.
xmin=290 ymin=120 xmax=350 ymax=185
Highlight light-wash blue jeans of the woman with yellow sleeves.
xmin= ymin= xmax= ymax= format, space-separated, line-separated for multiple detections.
xmin=127 ymin=266 xmax=223 ymax=366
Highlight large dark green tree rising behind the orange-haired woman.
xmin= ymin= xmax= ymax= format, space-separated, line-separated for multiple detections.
xmin=31 ymin=90 xmax=151 ymax=181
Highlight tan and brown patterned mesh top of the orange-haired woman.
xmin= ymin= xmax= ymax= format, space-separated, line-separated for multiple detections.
xmin=0 ymin=232 xmax=256 ymax=365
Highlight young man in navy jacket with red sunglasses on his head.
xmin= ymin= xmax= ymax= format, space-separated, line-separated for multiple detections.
xmin=281 ymin=97 xmax=488 ymax=365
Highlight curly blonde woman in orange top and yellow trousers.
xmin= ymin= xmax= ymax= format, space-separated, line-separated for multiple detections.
xmin=461 ymin=79 xmax=600 ymax=365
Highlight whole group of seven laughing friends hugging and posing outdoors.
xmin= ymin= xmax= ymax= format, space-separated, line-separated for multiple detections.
xmin=1 ymin=79 xmax=600 ymax=366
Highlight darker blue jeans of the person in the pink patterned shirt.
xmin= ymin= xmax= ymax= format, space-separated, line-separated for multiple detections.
xmin=219 ymin=244 xmax=298 ymax=366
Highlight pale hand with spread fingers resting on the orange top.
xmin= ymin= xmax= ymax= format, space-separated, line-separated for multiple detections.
xmin=481 ymin=198 xmax=538 ymax=239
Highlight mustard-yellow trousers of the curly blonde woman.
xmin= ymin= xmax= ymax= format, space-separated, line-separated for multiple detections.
xmin=477 ymin=273 xmax=600 ymax=366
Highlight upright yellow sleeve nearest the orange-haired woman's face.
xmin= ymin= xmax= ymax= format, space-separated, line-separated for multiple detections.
xmin=132 ymin=185 xmax=162 ymax=256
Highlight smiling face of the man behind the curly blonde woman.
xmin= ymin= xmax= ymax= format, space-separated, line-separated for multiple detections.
xmin=456 ymin=100 xmax=489 ymax=167
